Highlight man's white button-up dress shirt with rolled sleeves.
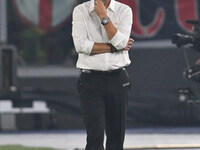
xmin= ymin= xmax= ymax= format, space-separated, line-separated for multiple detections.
xmin=72 ymin=0 xmax=133 ymax=71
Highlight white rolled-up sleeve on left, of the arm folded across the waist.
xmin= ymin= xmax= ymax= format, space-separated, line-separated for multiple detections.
xmin=72 ymin=7 xmax=94 ymax=55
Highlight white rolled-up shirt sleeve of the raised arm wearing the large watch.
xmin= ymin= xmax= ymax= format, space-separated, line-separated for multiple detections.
xmin=110 ymin=7 xmax=133 ymax=50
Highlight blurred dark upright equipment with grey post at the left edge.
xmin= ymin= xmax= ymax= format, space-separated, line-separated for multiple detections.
xmin=0 ymin=0 xmax=17 ymax=96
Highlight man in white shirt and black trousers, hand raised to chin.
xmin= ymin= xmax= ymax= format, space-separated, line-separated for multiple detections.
xmin=72 ymin=0 xmax=134 ymax=150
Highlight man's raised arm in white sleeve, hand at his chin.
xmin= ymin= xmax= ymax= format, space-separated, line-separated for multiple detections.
xmin=94 ymin=0 xmax=134 ymax=50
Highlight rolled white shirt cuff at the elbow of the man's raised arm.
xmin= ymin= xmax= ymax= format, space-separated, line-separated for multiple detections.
xmin=110 ymin=31 xmax=125 ymax=50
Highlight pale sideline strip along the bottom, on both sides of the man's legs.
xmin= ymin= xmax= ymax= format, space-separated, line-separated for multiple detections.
xmin=0 ymin=127 xmax=200 ymax=150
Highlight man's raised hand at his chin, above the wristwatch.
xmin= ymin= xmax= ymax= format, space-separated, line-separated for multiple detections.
xmin=94 ymin=0 xmax=108 ymax=20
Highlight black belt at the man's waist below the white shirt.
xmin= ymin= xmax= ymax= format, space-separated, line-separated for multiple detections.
xmin=81 ymin=67 xmax=126 ymax=74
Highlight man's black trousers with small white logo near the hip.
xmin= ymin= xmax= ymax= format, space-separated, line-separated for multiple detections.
xmin=78 ymin=68 xmax=130 ymax=150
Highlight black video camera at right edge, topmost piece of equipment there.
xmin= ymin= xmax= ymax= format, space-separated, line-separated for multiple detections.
xmin=172 ymin=20 xmax=200 ymax=52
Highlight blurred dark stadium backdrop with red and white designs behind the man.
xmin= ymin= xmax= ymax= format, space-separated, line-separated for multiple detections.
xmin=0 ymin=0 xmax=200 ymax=149
